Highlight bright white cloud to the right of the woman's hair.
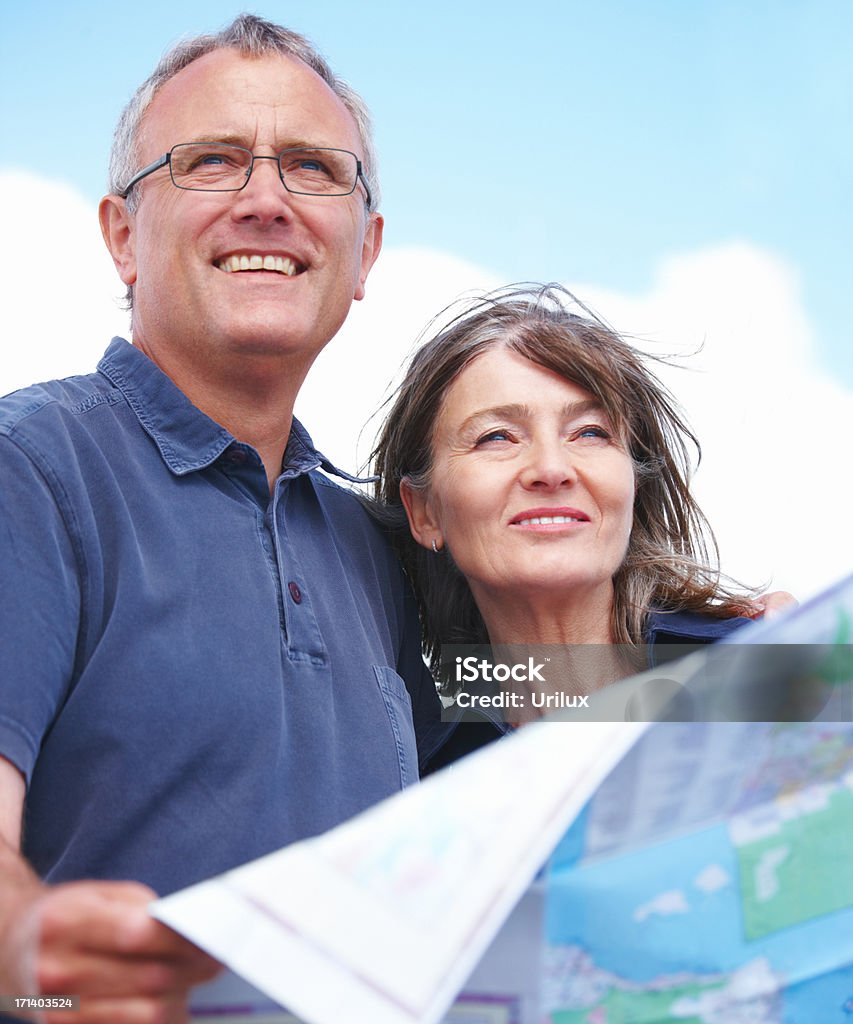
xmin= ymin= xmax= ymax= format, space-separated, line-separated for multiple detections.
xmin=582 ymin=243 xmax=853 ymax=598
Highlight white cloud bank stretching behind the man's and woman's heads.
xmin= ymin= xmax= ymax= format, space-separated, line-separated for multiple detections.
xmin=0 ymin=167 xmax=853 ymax=598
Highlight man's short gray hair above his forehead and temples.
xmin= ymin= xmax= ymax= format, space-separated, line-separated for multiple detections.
xmin=110 ymin=14 xmax=379 ymax=213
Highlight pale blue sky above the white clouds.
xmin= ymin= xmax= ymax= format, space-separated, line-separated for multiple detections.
xmin=0 ymin=0 xmax=853 ymax=385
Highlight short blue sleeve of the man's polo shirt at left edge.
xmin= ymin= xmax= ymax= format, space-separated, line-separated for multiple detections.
xmin=0 ymin=435 xmax=81 ymax=783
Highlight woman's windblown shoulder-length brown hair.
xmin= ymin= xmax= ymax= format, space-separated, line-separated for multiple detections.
xmin=372 ymin=285 xmax=744 ymax=670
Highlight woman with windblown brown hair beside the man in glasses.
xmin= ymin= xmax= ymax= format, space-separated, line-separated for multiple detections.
xmin=374 ymin=285 xmax=761 ymax=720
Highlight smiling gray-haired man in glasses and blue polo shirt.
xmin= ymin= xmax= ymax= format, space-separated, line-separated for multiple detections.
xmin=0 ymin=15 xmax=443 ymax=1024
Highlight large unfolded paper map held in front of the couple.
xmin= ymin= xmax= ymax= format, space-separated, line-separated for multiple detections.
xmin=153 ymin=579 xmax=853 ymax=1024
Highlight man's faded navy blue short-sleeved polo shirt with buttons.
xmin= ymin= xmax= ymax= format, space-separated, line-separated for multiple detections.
xmin=0 ymin=339 xmax=446 ymax=894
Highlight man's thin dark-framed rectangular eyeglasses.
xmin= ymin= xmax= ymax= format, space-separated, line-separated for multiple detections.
xmin=122 ymin=142 xmax=371 ymax=208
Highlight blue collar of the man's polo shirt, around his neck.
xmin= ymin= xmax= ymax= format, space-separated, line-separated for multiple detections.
xmin=97 ymin=338 xmax=369 ymax=483
